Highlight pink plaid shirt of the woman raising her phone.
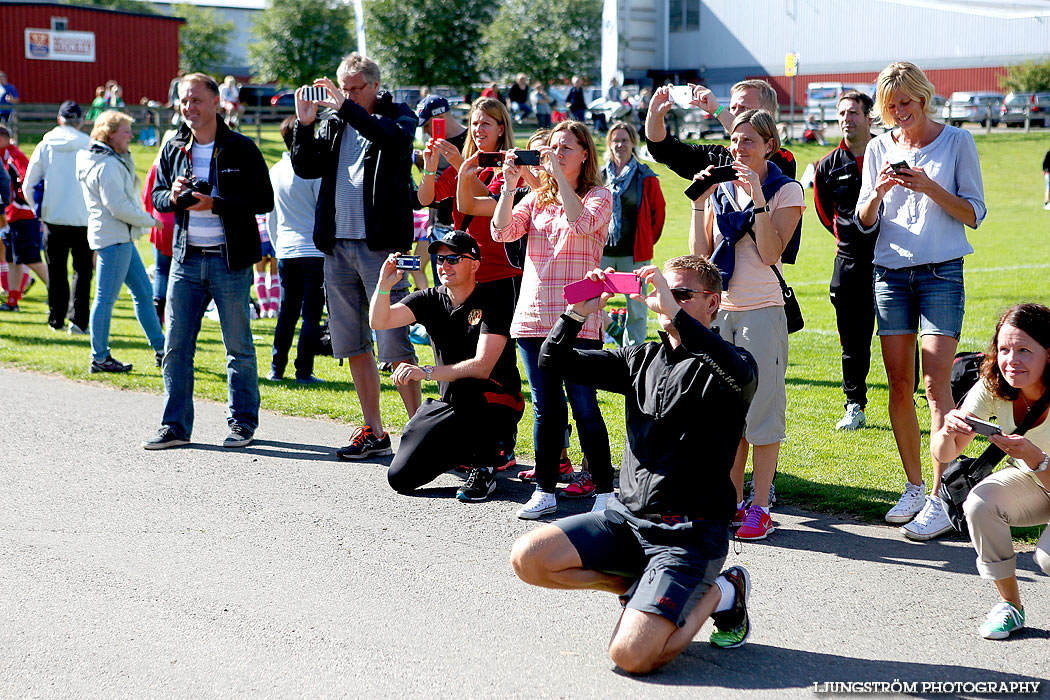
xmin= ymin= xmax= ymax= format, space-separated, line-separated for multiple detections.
xmin=492 ymin=187 xmax=612 ymax=340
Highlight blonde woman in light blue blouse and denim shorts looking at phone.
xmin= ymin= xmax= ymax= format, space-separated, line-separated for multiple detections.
xmin=857 ymin=62 xmax=986 ymax=540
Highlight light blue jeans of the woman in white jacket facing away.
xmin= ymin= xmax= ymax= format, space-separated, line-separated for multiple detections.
xmin=88 ymin=242 xmax=164 ymax=362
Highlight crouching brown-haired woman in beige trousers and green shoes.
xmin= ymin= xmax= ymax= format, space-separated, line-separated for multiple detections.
xmin=929 ymin=303 xmax=1050 ymax=639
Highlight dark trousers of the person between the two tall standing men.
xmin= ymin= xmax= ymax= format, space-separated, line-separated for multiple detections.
xmin=271 ymin=257 xmax=324 ymax=379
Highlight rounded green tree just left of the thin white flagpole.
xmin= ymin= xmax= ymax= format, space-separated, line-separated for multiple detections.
xmin=248 ymin=0 xmax=354 ymax=85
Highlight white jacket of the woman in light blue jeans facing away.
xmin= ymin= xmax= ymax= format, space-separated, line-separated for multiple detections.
xmin=77 ymin=141 xmax=153 ymax=250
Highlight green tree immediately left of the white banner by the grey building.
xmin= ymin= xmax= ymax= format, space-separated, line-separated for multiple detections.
xmin=482 ymin=0 xmax=602 ymax=82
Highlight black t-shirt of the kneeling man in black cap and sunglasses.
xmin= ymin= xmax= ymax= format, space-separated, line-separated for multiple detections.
xmin=401 ymin=284 xmax=521 ymax=405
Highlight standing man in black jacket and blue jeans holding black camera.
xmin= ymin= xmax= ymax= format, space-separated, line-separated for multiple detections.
xmin=142 ymin=73 xmax=273 ymax=449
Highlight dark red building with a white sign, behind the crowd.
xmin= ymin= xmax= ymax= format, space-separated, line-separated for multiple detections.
xmin=0 ymin=0 xmax=184 ymax=109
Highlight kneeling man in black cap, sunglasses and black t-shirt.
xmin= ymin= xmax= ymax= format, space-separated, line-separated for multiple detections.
xmin=369 ymin=231 xmax=525 ymax=502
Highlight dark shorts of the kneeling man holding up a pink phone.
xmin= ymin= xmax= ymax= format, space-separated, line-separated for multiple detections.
xmin=554 ymin=503 xmax=729 ymax=627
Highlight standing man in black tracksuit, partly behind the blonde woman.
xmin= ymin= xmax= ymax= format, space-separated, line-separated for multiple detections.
xmin=813 ymin=90 xmax=878 ymax=430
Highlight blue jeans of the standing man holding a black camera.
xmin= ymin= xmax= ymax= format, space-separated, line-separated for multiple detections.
xmin=163 ymin=247 xmax=259 ymax=440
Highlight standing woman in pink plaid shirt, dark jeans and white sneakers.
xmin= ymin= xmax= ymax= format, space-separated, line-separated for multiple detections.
xmin=492 ymin=122 xmax=613 ymax=519
